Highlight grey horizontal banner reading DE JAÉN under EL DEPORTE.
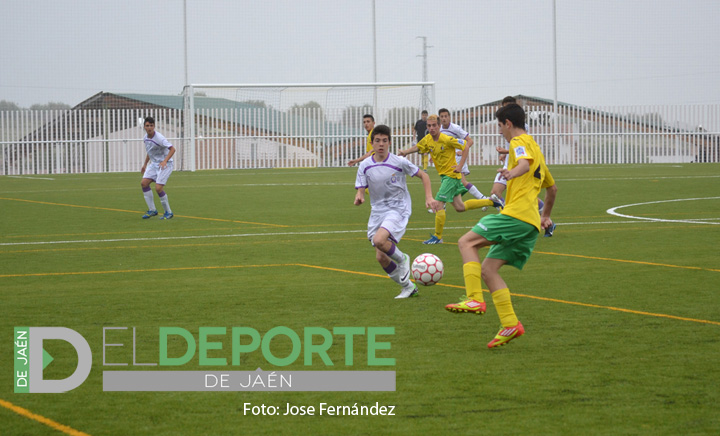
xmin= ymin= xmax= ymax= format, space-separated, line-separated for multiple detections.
xmin=103 ymin=369 xmax=395 ymax=392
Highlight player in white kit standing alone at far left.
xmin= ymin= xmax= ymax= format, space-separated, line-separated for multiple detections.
xmin=140 ymin=117 xmax=175 ymax=220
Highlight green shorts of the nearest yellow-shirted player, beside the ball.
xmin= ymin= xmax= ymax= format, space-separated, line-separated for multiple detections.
xmin=472 ymin=214 xmax=540 ymax=269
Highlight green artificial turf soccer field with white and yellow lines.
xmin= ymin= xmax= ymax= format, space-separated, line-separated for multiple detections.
xmin=0 ymin=164 xmax=720 ymax=435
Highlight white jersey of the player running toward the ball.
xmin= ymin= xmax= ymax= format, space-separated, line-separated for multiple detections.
xmin=355 ymin=153 xmax=420 ymax=217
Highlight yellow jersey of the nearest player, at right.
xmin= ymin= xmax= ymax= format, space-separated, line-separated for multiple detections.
xmin=500 ymin=134 xmax=555 ymax=231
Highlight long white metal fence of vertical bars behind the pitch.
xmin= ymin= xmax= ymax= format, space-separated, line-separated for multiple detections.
xmin=0 ymin=105 xmax=720 ymax=175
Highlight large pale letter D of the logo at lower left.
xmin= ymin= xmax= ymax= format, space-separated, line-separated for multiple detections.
xmin=28 ymin=327 xmax=92 ymax=393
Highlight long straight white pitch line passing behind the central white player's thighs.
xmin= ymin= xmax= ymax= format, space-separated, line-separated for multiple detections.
xmin=0 ymin=220 xmax=688 ymax=247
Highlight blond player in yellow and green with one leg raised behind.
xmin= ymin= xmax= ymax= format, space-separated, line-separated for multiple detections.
xmin=398 ymin=115 xmax=501 ymax=244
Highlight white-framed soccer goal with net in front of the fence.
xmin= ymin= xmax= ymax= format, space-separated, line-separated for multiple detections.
xmin=183 ymin=82 xmax=435 ymax=171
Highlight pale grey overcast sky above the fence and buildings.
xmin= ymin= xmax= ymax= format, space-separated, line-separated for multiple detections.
xmin=0 ymin=0 xmax=720 ymax=108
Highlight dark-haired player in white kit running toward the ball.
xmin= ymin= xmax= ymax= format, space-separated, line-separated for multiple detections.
xmin=355 ymin=125 xmax=443 ymax=298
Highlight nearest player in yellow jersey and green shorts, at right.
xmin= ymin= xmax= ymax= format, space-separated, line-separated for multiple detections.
xmin=445 ymin=103 xmax=557 ymax=348
